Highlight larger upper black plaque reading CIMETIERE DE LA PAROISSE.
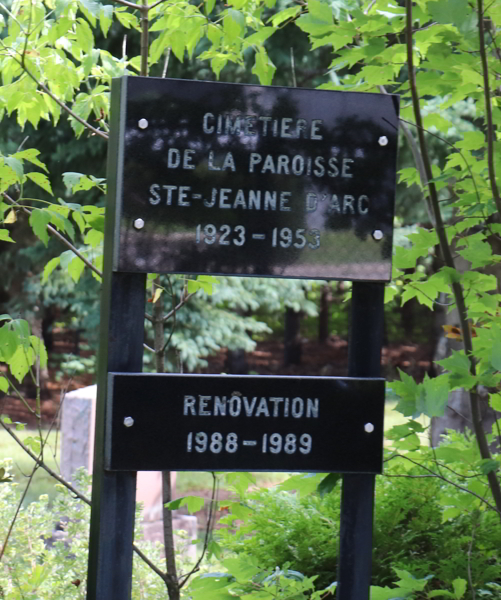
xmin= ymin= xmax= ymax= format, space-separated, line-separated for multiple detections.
xmin=111 ymin=77 xmax=398 ymax=281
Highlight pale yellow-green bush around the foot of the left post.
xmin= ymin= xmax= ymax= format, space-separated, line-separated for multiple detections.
xmin=0 ymin=461 xmax=184 ymax=600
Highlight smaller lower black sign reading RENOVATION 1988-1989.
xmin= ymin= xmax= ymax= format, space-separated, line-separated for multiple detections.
xmin=105 ymin=373 xmax=384 ymax=473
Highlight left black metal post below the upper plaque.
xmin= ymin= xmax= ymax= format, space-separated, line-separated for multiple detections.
xmin=87 ymin=268 xmax=146 ymax=600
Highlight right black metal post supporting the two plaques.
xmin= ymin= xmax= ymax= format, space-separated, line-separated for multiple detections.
xmin=336 ymin=282 xmax=384 ymax=600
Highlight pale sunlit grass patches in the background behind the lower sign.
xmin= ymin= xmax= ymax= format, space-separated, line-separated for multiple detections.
xmin=0 ymin=401 xmax=429 ymax=504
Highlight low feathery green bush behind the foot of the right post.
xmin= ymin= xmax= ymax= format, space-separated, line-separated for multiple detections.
xmin=219 ymin=463 xmax=501 ymax=598
